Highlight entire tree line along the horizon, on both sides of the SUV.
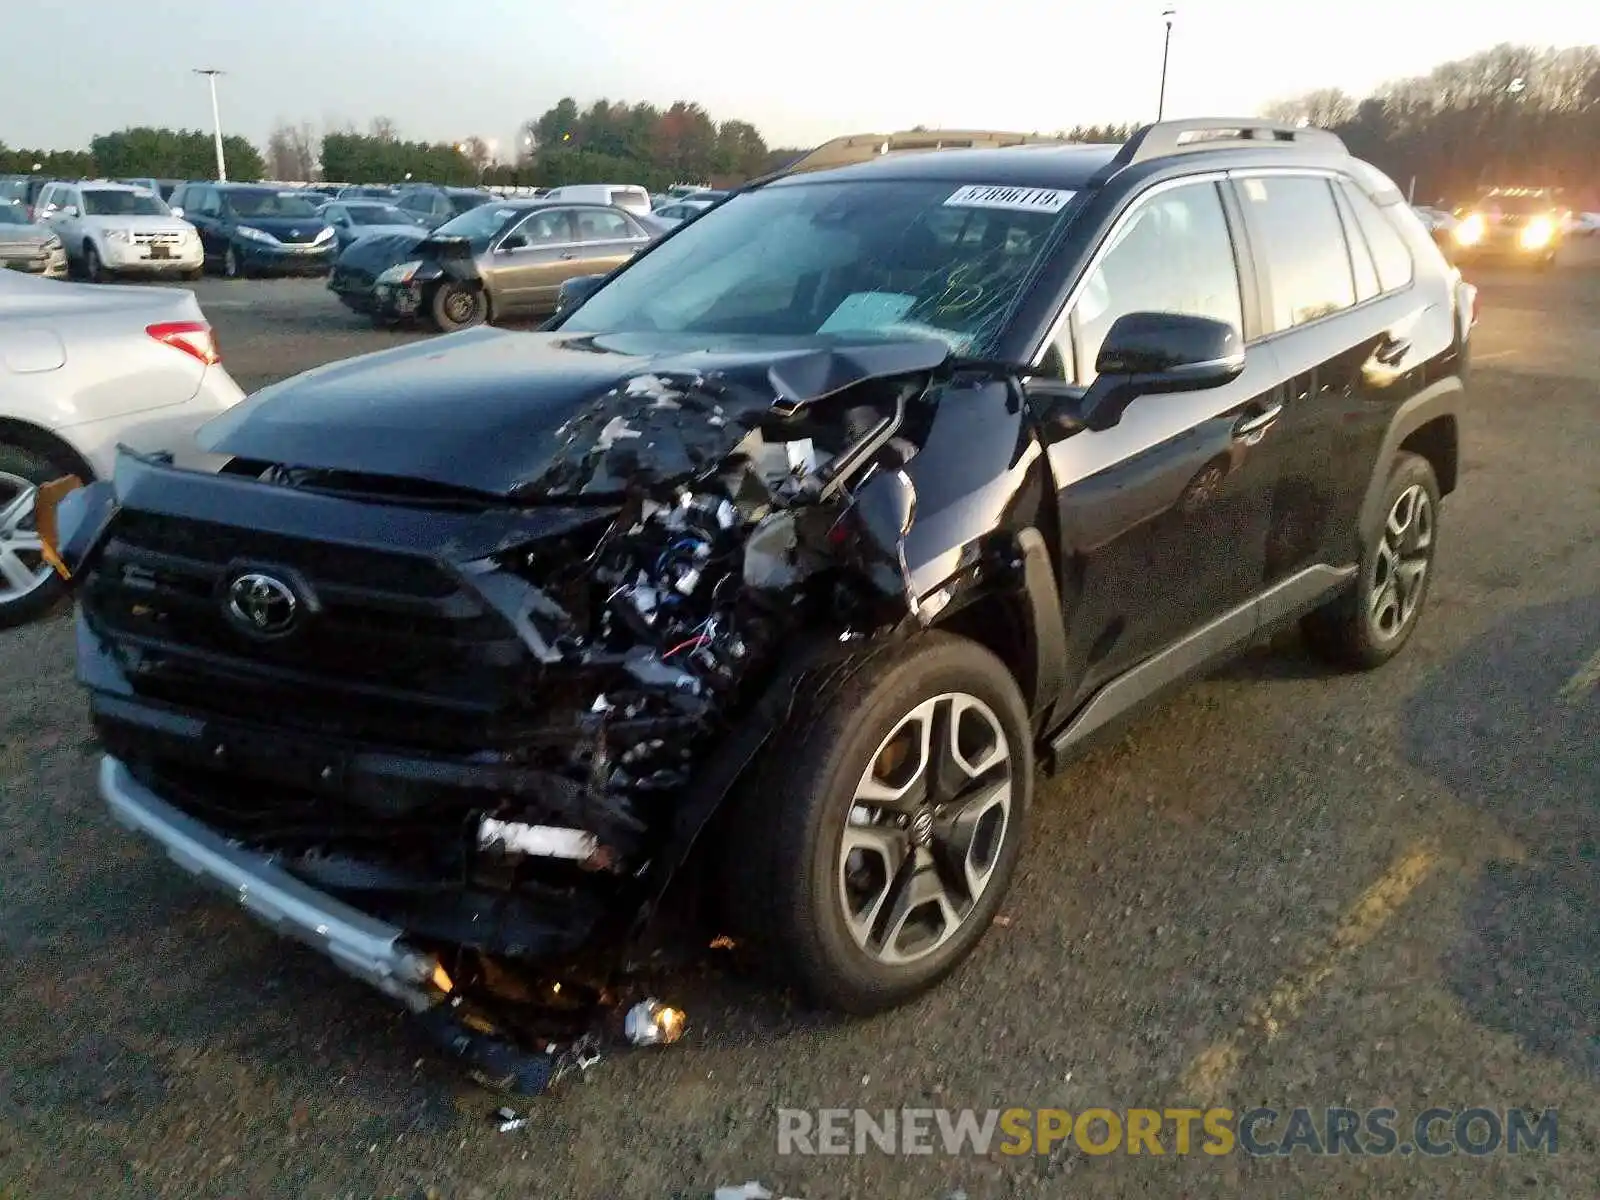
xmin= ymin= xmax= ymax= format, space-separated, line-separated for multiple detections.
xmin=0 ymin=45 xmax=1600 ymax=203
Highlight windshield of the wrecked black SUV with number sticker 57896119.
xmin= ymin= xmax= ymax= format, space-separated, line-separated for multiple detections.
xmin=562 ymin=181 xmax=1072 ymax=354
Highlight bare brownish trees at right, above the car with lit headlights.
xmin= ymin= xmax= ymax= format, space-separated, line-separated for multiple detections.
xmin=1266 ymin=45 xmax=1600 ymax=208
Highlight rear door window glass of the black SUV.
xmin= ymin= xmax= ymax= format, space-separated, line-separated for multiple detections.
xmin=1238 ymin=176 xmax=1355 ymax=333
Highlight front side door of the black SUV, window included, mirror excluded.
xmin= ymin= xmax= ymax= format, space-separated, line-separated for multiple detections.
xmin=1040 ymin=174 xmax=1282 ymax=696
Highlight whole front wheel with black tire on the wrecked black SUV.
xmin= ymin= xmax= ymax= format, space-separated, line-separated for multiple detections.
xmin=723 ymin=634 xmax=1034 ymax=1014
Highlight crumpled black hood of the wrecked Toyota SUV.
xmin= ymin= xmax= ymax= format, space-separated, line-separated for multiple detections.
xmin=198 ymin=324 xmax=949 ymax=501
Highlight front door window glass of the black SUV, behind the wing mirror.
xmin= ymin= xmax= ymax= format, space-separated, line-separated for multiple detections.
xmin=1062 ymin=182 xmax=1243 ymax=384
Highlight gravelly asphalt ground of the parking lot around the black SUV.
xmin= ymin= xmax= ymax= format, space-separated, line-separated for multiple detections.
xmin=0 ymin=254 xmax=1600 ymax=1200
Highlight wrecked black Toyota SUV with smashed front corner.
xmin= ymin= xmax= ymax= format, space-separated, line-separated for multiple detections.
xmin=56 ymin=120 xmax=1474 ymax=1013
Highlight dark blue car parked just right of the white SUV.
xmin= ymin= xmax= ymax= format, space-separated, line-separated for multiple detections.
xmin=173 ymin=182 xmax=339 ymax=278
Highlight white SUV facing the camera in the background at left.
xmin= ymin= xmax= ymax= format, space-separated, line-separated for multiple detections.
xmin=35 ymin=182 xmax=205 ymax=283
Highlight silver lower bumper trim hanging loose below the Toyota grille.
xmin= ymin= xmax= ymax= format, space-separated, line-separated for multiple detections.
xmin=99 ymin=755 xmax=445 ymax=1013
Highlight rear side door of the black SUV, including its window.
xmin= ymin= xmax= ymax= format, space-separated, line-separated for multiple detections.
xmin=1232 ymin=170 xmax=1426 ymax=584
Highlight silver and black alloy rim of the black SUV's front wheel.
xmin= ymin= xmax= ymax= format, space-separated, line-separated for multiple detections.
xmin=838 ymin=693 xmax=1016 ymax=966
